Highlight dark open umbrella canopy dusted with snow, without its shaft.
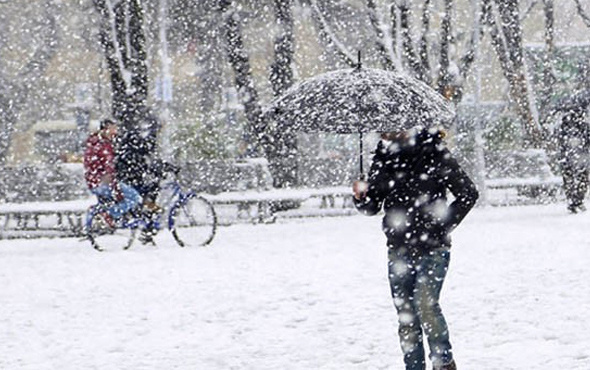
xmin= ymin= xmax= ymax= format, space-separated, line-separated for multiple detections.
xmin=265 ymin=67 xmax=454 ymax=133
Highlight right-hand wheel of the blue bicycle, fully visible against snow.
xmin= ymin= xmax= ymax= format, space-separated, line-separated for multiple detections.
xmin=169 ymin=194 xmax=217 ymax=247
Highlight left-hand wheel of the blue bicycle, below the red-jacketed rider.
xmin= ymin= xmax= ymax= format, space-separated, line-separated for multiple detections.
xmin=86 ymin=210 xmax=137 ymax=252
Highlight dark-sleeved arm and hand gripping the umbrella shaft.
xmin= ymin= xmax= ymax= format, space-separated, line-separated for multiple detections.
xmin=352 ymin=143 xmax=390 ymax=216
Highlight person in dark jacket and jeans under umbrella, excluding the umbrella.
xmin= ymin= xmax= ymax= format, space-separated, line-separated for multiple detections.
xmin=353 ymin=128 xmax=479 ymax=370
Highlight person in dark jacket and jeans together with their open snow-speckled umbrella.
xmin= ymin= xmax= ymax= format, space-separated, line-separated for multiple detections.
xmin=264 ymin=60 xmax=470 ymax=370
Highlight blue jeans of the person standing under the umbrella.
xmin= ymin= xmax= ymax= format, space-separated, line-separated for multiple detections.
xmin=389 ymin=246 xmax=453 ymax=370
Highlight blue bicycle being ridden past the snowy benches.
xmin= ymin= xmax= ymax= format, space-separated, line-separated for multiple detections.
xmin=85 ymin=171 xmax=217 ymax=251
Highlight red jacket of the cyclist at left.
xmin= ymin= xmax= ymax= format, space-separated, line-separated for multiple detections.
xmin=84 ymin=132 xmax=116 ymax=189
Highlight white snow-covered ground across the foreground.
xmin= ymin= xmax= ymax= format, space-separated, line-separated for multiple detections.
xmin=0 ymin=204 xmax=590 ymax=370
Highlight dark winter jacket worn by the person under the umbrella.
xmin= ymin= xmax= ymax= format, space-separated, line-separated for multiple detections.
xmin=353 ymin=130 xmax=479 ymax=250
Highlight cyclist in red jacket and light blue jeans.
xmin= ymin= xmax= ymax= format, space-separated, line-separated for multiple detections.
xmin=84 ymin=119 xmax=141 ymax=228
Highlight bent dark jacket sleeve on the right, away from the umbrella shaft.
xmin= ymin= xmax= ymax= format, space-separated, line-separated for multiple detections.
xmin=441 ymin=149 xmax=479 ymax=232
